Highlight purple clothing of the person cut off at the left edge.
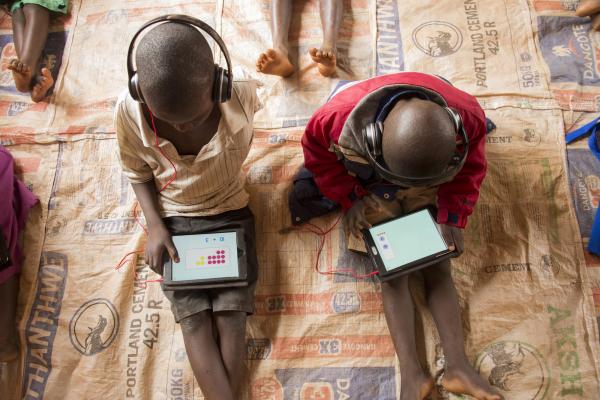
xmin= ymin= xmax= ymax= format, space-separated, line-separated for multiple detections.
xmin=0 ymin=146 xmax=38 ymax=284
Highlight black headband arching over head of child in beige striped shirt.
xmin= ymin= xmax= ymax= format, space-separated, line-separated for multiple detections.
xmin=127 ymin=14 xmax=233 ymax=101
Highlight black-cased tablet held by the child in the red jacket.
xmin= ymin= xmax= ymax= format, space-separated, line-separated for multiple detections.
xmin=363 ymin=209 xmax=458 ymax=281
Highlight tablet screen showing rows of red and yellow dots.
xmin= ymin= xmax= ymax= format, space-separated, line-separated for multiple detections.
xmin=172 ymin=232 xmax=239 ymax=282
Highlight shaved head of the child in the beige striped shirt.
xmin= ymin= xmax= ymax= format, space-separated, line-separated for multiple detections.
xmin=136 ymin=22 xmax=215 ymax=122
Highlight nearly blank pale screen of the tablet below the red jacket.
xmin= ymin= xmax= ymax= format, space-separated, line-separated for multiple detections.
xmin=369 ymin=210 xmax=448 ymax=271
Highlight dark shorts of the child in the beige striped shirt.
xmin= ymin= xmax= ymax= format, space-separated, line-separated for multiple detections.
xmin=163 ymin=207 xmax=258 ymax=322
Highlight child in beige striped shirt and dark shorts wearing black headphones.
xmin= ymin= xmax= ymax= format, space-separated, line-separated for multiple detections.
xmin=115 ymin=15 xmax=260 ymax=400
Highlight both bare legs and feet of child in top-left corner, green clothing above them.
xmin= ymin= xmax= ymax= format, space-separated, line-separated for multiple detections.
xmin=0 ymin=0 xmax=68 ymax=103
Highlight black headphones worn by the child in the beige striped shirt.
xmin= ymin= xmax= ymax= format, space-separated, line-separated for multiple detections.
xmin=127 ymin=14 xmax=233 ymax=103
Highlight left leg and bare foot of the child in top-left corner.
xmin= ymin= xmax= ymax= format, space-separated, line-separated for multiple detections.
xmin=8 ymin=4 xmax=50 ymax=92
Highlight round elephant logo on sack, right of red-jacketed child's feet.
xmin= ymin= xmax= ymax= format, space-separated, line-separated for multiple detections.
xmin=475 ymin=340 xmax=550 ymax=400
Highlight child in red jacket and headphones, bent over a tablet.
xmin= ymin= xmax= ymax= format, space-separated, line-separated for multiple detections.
xmin=298 ymin=72 xmax=502 ymax=400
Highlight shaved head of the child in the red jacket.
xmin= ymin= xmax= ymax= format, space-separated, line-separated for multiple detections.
xmin=381 ymin=98 xmax=456 ymax=178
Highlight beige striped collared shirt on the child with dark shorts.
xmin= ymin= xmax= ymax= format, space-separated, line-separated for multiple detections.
xmin=115 ymin=81 xmax=260 ymax=217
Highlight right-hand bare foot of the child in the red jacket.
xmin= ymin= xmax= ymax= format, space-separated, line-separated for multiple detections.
xmin=442 ymin=365 xmax=504 ymax=400
